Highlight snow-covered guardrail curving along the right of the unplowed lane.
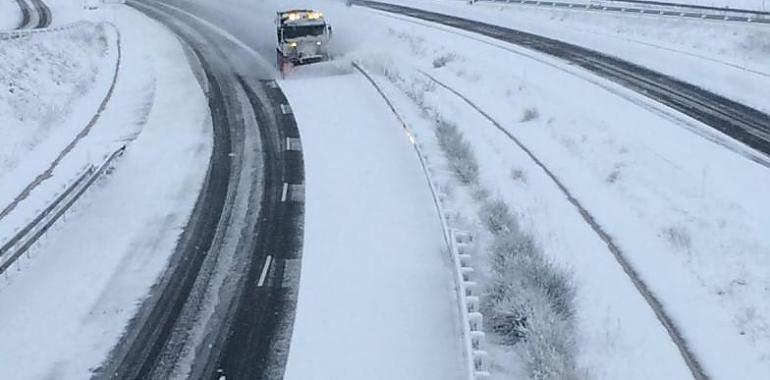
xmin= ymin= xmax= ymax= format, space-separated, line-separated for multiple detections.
xmin=353 ymin=62 xmax=489 ymax=380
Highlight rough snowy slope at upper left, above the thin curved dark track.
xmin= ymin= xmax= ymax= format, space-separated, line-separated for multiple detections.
xmin=0 ymin=23 xmax=111 ymax=184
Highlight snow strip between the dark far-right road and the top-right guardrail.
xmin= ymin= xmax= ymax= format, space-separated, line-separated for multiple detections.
xmin=389 ymin=0 xmax=770 ymax=116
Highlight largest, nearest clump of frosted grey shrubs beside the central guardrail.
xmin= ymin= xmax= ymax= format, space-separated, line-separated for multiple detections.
xmin=480 ymin=199 xmax=581 ymax=380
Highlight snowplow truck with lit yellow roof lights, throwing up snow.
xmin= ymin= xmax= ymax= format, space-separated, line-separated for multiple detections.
xmin=275 ymin=9 xmax=332 ymax=73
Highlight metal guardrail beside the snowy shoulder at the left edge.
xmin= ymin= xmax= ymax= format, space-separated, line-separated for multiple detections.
xmin=0 ymin=145 xmax=126 ymax=274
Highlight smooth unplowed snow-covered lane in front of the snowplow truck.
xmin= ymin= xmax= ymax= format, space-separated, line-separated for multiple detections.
xmin=281 ymin=70 xmax=463 ymax=380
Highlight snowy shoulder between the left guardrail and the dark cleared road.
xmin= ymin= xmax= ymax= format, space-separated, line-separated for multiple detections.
xmin=0 ymin=4 xmax=212 ymax=380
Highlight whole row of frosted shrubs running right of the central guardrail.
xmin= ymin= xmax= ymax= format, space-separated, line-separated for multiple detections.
xmin=383 ymin=63 xmax=580 ymax=380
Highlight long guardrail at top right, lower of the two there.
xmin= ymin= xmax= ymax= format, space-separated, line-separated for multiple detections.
xmin=469 ymin=0 xmax=770 ymax=24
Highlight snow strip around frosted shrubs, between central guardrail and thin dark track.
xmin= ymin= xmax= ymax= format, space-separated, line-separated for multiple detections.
xmin=368 ymin=57 xmax=689 ymax=379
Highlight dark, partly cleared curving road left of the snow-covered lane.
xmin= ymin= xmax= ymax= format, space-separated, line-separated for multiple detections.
xmin=95 ymin=1 xmax=304 ymax=379
